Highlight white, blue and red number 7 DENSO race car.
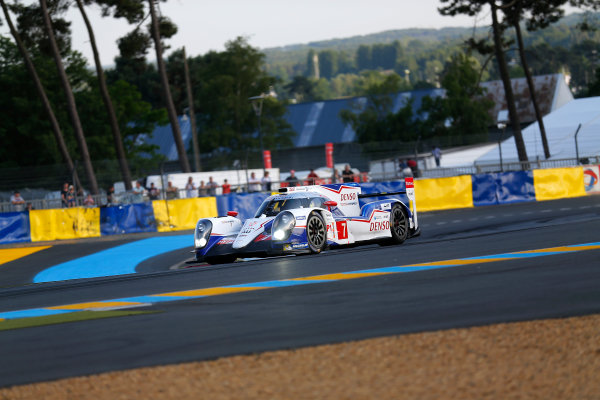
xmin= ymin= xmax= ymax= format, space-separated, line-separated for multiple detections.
xmin=193 ymin=178 xmax=420 ymax=264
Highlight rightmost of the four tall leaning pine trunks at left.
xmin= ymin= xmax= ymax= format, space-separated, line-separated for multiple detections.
xmin=148 ymin=0 xmax=191 ymax=172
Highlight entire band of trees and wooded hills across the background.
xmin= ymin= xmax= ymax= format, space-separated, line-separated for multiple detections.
xmin=0 ymin=0 xmax=600 ymax=193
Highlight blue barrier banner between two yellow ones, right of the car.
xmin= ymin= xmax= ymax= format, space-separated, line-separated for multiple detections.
xmin=471 ymin=171 xmax=535 ymax=206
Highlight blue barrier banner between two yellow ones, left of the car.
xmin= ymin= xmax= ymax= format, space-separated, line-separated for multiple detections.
xmin=100 ymin=202 xmax=156 ymax=236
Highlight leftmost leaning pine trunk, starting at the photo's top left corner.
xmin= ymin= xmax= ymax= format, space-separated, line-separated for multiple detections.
xmin=0 ymin=0 xmax=80 ymax=184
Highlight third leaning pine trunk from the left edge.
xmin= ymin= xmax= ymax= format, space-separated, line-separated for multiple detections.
xmin=76 ymin=0 xmax=132 ymax=190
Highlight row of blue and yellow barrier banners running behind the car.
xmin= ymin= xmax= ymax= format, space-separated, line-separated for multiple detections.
xmin=0 ymin=165 xmax=600 ymax=244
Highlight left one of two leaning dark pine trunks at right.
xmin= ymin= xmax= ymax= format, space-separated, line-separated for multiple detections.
xmin=438 ymin=0 xmax=528 ymax=162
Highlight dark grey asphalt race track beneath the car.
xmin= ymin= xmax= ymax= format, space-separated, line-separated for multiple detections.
xmin=0 ymin=196 xmax=600 ymax=386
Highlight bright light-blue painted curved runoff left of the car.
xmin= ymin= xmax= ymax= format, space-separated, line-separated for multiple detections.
xmin=33 ymin=234 xmax=194 ymax=283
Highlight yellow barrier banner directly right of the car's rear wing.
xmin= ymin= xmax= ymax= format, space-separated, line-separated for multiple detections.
xmin=415 ymin=175 xmax=473 ymax=211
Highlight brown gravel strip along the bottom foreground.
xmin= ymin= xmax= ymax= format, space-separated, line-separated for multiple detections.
xmin=0 ymin=315 xmax=600 ymax=400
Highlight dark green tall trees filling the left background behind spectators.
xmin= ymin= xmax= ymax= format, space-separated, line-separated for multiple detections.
xmin=0 ymin=0 xmax=293 ymax=193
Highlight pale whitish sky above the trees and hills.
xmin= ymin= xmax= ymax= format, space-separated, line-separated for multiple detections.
xmin=67 ymin=0 xmax=488 ymax=65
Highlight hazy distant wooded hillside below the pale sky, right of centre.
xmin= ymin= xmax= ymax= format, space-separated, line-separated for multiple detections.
xmin=266 ymin=9 xmax=600 ymax=101
